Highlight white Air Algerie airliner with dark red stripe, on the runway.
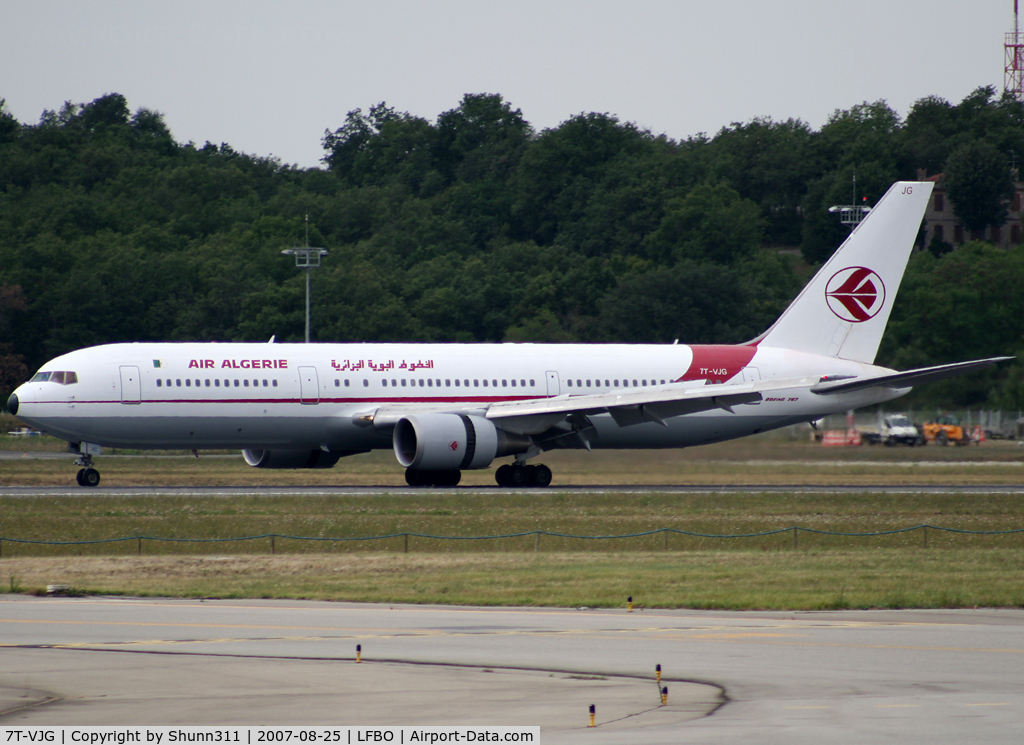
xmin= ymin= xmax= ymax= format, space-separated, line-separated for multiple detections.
xmin=8 ymin=182 xmax=1010 ymax=486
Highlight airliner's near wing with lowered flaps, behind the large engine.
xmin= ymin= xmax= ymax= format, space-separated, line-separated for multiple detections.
xmin=485 ymin=378 xmax=816 ymax=433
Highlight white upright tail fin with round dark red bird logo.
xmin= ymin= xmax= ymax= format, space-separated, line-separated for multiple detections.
xmin=751 ymin=181 xmax=934 ymax=363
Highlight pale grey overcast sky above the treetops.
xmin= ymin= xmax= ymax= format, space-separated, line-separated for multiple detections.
xmin=0 ymin=0 xmax=1013 ymax=167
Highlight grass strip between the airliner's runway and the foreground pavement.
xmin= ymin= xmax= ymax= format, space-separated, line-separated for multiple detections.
xmin=0 ymin=489 xmax=1024 ymax=609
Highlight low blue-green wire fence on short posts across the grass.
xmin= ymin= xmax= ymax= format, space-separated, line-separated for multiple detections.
xmin=0 ymin=524 xmax=1024 ymax=559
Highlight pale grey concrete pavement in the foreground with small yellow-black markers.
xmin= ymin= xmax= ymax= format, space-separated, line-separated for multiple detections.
xmin=0 ymin=597 xmax=1024 ymax=744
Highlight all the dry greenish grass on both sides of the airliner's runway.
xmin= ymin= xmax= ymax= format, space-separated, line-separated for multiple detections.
xmin=0 ymin=413 xmax=1024 ymax=609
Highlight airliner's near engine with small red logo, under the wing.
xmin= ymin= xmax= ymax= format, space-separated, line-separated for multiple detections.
xmin=393 ymin=413 xmax=534 ymax=471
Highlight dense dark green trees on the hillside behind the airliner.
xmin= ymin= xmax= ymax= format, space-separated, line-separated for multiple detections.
xmin=0 ymin=88 xmax=1024 ymax=406
